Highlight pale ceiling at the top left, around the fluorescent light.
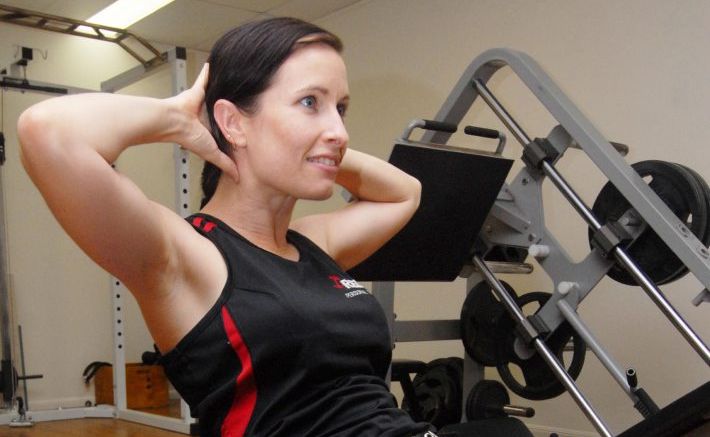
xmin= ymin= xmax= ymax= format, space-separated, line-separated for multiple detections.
xmin=0 ymin=0 xmax=362 ymax=51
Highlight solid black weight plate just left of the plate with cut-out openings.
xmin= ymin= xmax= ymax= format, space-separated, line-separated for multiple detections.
xmin=461 ymin=281 xmax=516 ymax=366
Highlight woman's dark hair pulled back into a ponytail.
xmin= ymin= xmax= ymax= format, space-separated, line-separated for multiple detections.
xmin=200 ymin=17 xmax=342 ymax=208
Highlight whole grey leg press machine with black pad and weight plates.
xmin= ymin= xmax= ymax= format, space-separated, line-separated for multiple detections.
xmin=351 ymin=49 xmax=710 ymax=437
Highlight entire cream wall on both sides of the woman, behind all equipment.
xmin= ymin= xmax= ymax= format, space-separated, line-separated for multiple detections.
xmin=0 ymin=0 xmax=710 ymax=435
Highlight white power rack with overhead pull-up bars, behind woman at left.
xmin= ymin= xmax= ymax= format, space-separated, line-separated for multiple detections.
xmin=0 ymin=5 xmax=197 ymax=434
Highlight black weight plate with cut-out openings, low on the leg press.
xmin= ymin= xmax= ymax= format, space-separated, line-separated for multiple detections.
xmin=497 ymin=291 xmax=587 ymax=400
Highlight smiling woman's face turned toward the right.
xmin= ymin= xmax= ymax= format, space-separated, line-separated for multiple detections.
xmin=238 ymin=43 xmax=348 ymax=200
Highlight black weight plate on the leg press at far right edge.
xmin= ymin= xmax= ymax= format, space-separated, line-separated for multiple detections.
xmin=589 ymin=160 xmax=708 ymax=285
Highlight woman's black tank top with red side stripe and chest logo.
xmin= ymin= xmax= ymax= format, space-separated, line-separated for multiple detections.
xmin=162 ymin=214 xmax=428 ymax=437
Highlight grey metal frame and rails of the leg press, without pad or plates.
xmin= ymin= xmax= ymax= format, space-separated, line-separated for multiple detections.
xmin=372 ymin=49 xmax=710 ymax=436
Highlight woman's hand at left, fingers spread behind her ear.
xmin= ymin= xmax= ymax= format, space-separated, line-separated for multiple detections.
xmin=168 ymin=64 xmax=239 ymax=182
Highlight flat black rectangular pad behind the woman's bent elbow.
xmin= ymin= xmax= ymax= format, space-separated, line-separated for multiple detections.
xmin=349 ymin=143 xmax=513 ymax=281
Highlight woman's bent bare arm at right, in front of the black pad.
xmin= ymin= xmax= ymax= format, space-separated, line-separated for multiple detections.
xmin=293 ymin=149 xmax=421 ymax=270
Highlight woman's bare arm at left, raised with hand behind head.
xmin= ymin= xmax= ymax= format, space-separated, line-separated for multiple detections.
xmin=18 ymin=64 xmax=236 ymax=292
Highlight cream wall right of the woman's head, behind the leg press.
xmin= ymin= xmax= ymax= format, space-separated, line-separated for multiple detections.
xmin=320 ymin=0 xmax=710 ymax=435
